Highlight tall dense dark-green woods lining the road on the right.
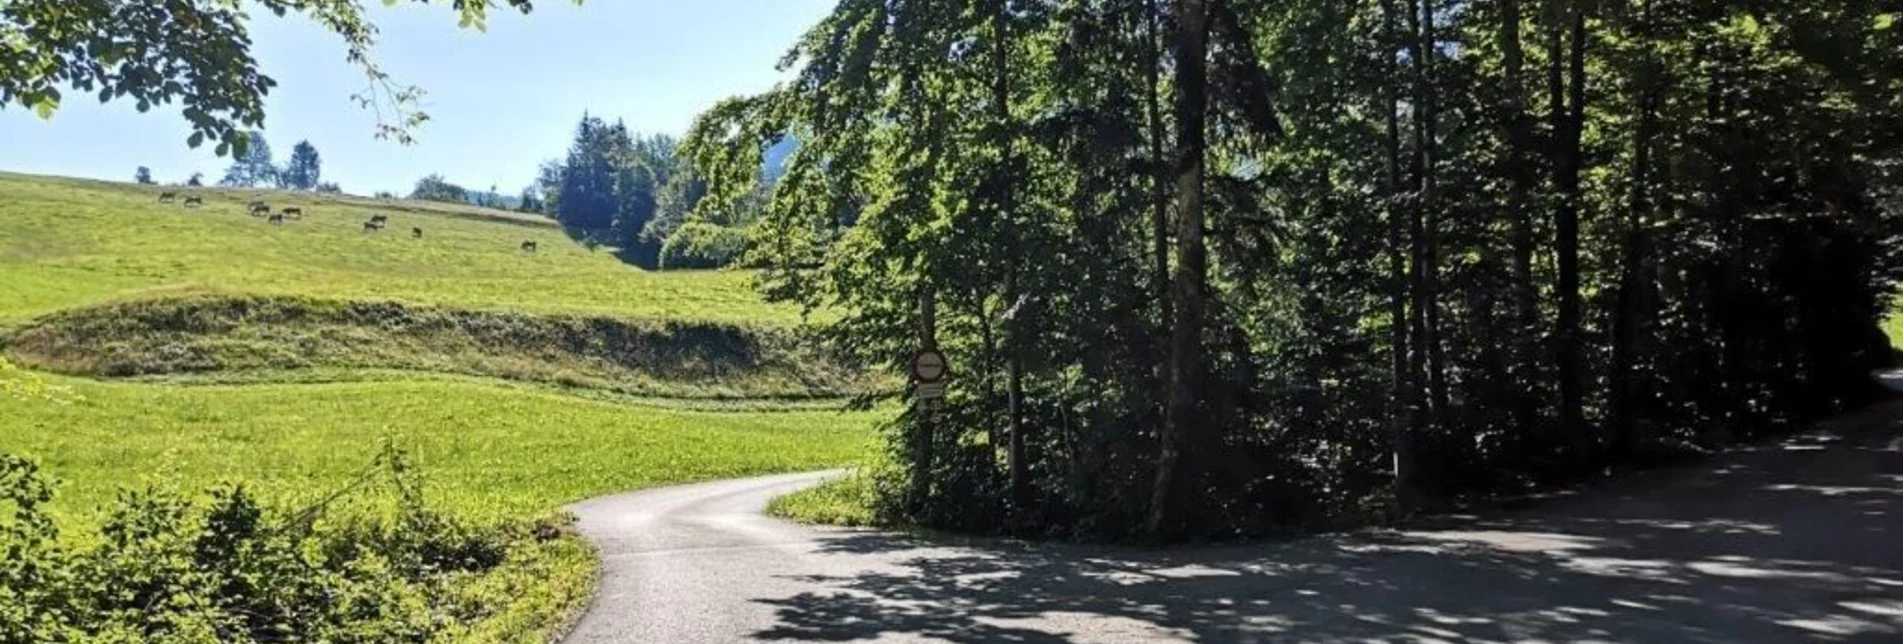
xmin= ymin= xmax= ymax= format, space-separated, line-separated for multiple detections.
xmin=681 ymin=0 xmax=1903 ymax=539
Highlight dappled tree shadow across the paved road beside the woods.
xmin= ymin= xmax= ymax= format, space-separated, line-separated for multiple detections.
xmin=755 ymin=405 xmax=1903 ymax=642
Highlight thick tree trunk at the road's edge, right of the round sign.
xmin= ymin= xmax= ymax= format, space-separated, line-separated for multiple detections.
xmin=1146 ymin=0 xmax=1208 ymax=537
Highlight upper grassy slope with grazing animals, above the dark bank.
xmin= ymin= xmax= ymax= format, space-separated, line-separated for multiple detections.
xmin=0 ymin=173 xmax=797 ymax=324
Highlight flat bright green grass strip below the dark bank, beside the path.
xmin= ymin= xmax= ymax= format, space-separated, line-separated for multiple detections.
xmin=0 ymin=371 xmax=875 ymax=522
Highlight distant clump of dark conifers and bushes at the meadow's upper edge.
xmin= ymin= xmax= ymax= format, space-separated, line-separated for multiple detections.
xmin=523 ymin=114 xmax=776 ymax=269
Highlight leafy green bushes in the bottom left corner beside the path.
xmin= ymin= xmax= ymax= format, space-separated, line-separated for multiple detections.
xmin=0 ymin=450 xmax=578 ymax=642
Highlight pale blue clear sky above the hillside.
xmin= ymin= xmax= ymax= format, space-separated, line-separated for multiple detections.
xmin=0 ymin=0 xmax=832 ymax=194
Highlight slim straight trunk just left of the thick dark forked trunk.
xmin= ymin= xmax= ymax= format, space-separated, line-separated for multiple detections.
xmin=1500 ymin=0 xmax=1540 ymax=438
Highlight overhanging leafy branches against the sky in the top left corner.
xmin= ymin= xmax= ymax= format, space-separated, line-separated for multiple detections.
xmin=0 ymin=0 xmax=531 ymax=156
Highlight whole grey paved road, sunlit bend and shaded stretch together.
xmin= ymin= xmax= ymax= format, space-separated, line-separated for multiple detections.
xmin=569 ymin=404 xmax=1903 ymax=644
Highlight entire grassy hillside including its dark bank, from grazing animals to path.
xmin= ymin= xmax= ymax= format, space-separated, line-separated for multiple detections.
xmin=0 ymin=173 xmax=883 ymax=640
